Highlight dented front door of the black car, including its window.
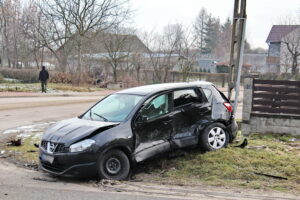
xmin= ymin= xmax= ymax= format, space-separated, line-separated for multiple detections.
xmin=133 ymin=93 xmax=173 ymax=162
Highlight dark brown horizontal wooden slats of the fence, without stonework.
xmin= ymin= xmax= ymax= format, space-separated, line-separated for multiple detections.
xmin=252 ymin=79 xmax=300 ymax=115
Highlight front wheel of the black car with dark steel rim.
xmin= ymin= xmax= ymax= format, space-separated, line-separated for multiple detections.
xmin=98 ymin=149 xmax=130 ymax=180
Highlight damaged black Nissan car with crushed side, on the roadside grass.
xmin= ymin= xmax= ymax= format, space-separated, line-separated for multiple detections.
xmin=39 ymin=81 xmax=237 ymax=180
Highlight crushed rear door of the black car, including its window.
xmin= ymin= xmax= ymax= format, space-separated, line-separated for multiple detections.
xmin=172 ymin=88 xmax=210 ymax=148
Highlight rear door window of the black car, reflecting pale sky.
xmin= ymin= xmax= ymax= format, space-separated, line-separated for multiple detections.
xmin=173 ymin=89 xmax=202 ymax=107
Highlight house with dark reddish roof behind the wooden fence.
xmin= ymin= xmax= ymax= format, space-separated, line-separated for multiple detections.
xmin=266 ymin=25 xmax=300 ymax=73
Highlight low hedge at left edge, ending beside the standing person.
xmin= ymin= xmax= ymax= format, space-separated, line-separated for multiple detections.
xmin=0 ymin=68 xmax=39 ymax=83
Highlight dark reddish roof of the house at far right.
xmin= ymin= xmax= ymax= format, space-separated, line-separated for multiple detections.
xmin=266 ymin=25 xmax=300 ymax=43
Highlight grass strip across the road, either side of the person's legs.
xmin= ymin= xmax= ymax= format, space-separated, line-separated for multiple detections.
xmin=0 ymin=83 xmax=103 ymax=92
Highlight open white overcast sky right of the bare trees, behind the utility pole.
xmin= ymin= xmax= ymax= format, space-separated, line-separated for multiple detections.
xmin=131 ymin=0 xmax=300 ymax=48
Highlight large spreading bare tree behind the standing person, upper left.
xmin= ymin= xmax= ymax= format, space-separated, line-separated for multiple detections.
xmin=38 ymin=0 xmax=130 ymax=81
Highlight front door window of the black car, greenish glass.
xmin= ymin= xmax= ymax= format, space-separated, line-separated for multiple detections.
xmin=141 ymin=94 xmax=170 ymax=120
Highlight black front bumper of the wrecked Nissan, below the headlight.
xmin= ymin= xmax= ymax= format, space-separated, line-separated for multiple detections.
xmin=39 ymin=148 xmax=98 ymax=177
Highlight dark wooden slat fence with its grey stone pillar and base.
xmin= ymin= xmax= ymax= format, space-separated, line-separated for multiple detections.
xmin=242 ymin=78 xmax=300 ymax=135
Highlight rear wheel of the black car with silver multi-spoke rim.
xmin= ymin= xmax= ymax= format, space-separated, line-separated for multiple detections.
xmin=199 ymin=123 xmax=229 ymax=151
